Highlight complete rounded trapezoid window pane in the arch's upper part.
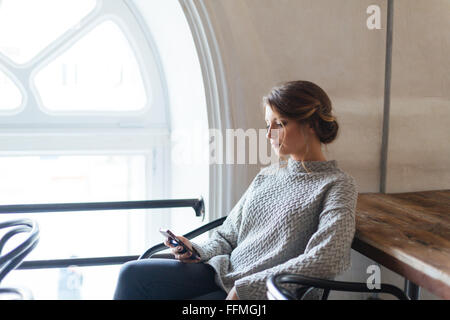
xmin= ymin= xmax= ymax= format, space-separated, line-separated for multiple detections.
xmin=35 ymin=21 xmax=147 ymax=111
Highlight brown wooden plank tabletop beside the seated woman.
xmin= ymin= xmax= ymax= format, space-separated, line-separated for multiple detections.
xmin=352 ymin=190 xmax=450 ymax=299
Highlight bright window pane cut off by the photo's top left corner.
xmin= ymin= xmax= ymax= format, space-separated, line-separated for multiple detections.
xmin=0 ymin=0 xmax=96 ymax=64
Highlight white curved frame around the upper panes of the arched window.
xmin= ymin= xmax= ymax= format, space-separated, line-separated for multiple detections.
xmin=0 ymin=0 xmax=169 ymax=132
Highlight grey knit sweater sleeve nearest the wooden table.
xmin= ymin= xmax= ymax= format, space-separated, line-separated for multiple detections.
xmin=234 ymin=177 xmax=358 ymax=300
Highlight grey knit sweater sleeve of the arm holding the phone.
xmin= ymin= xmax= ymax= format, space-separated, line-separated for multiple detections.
xmin=191 ymin=183 xmax=253 ymax=261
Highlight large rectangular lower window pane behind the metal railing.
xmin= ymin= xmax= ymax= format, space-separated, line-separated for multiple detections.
xmin=0 ymin=155 xmax=148 ymax=259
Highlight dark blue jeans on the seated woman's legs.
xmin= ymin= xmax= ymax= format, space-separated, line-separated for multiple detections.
xmin=114 ymin=258 xmax=227 ymax=300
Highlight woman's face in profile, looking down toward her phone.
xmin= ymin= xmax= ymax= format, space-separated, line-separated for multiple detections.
xmin=265 ymin=105 xmax=306 ymax=156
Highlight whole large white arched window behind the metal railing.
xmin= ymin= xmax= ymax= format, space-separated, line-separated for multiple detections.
xmin=0 ymin=0 xmax=209 ymax=299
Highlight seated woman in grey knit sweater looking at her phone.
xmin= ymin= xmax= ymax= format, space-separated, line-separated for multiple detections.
xmin=115 ymin=81 xmax=357 ymax=299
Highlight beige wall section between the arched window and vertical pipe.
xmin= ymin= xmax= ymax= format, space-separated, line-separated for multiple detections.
xmin=204 ymin=0 xmax=387 ymax=192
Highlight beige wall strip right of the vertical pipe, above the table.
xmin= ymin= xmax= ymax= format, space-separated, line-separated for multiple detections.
xmin=386 ymin=0 xmax=450 ymax=193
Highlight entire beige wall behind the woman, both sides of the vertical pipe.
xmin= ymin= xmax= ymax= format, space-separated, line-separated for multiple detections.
xmin=196 ymin=0 xmax=450 ymax=299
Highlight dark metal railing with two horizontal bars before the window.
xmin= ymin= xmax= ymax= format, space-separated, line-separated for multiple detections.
xmin=0 ymin=197 xmax=205 ymax=269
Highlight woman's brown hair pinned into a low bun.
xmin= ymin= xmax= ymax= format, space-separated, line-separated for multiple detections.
xmin=263 ymin=80 xmax=339 ymax=171
